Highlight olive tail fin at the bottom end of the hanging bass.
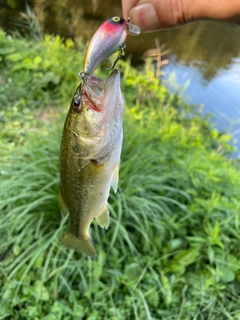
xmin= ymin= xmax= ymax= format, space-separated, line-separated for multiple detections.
xmin=61 ymin=232 xmax=97 ymax=258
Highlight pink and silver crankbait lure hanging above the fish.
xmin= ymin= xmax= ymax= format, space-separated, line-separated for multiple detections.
xmin=83 ymin=17 xmax=140 ymax=75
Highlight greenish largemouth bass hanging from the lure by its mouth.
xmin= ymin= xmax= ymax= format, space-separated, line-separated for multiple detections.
xmin=59 ymin=69 xmax=124 ymax=258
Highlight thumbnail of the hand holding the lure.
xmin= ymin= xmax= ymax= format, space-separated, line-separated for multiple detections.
xmin=130 ymin=3 xmax=160 ymax=32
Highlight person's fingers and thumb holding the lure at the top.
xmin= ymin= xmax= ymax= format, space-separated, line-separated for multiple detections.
xmin=122 ymin=0 xmax=240 ymax=32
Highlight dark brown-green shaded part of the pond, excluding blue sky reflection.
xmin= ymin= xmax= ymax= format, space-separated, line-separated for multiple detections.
xmin=0 ymin=0 xmax=240 ymax=83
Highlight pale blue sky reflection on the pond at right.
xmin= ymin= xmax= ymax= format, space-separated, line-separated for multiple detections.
xmin=163 ymin=56 xmax=240 ymax=157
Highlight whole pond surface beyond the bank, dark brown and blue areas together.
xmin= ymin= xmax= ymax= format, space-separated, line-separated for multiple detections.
xmin=0 ymin=0 xmax=240 ymax=157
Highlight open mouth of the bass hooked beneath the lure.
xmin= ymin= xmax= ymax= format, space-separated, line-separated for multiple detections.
xmin=81 ymin=69 xmax=120 ymax=112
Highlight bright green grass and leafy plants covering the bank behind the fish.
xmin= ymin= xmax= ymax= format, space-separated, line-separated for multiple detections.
xmin=0 ymin=26 xmax=240 ymax=320
